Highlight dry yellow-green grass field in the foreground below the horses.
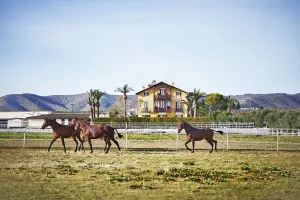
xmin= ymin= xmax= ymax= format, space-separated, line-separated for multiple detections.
xmin=0 ymin=145 xmax=300 ymax=199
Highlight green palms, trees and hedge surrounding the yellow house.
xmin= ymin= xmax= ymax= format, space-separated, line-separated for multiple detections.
xmin=88 ymin=84 xmax=300 ymax=128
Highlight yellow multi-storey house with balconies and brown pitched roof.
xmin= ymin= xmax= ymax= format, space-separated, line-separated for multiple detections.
xmin=136 ymin=81 xmax=187 ymax=117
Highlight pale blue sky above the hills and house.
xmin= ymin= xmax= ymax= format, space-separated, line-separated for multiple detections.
xmin=0 ymin=0 xmax=300 ymax=96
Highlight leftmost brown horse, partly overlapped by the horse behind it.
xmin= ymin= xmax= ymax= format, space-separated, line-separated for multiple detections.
xmin=42 ymin=118 xmax=84 ymax=153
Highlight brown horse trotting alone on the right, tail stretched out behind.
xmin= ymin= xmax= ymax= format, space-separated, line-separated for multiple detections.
xmin=178 ymin=121 xmax=223 ymax=153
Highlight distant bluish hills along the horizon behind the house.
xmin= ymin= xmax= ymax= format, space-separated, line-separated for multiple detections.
xmin=0 ymin=93 xmax=300 ymax=112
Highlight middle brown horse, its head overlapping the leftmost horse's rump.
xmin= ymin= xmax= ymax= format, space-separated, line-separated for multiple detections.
xmin=75 ymin=118 xmax=123 ymax=153
